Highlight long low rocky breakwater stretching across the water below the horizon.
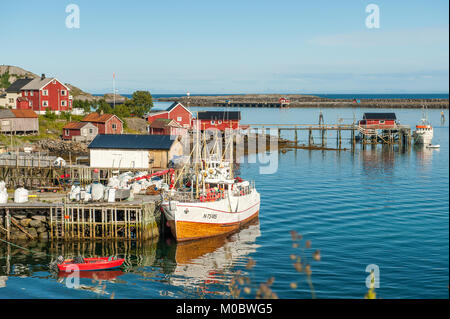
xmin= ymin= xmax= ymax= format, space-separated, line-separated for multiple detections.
xmin=157 ymin=94 xmax=449 ymax=109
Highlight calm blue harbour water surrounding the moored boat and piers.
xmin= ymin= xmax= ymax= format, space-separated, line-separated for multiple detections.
xmin=0 ymin=107 xmax=449 ymax=298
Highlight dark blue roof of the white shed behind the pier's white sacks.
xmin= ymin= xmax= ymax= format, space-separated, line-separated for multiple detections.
xmin=88 ymin=134 xmax=176 ymax=150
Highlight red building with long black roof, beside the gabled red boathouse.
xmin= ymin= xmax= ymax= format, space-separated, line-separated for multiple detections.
xmin=197 ymin=111 xmax=241 ymax=131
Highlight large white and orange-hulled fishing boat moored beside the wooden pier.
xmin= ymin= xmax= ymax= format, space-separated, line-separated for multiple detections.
xmin=161 ymin=129 xmax=260 ymax=242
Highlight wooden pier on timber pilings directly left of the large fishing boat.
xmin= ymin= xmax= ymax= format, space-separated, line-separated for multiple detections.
xmin=0 ymin=196 xmax=161 ymax=241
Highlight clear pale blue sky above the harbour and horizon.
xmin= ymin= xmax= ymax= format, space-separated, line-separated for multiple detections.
xmin=0 ymin=0 xmax=449 ymax=94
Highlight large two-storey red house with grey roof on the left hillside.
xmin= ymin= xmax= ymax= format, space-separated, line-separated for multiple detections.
xmin=20 ymin=74 xmax=72 ymax=114
